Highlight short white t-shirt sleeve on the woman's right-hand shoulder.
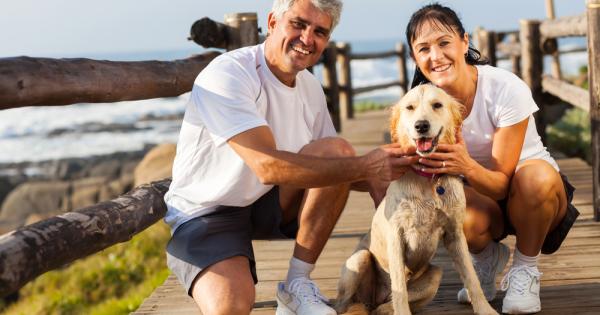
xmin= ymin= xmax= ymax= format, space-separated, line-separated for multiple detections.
xmin=495 ymin=76 xmax=539 ymax=128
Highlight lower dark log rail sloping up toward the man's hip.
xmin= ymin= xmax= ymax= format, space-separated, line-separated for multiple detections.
xmin=0 ymin=179 xmax=171 ymax=297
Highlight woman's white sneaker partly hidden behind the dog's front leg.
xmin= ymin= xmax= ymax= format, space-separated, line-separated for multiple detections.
xmin=457 ymin=243 xmax=510 ymax=303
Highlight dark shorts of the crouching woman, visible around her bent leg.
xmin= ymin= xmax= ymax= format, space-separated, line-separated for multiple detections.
xmin=496 ymin=173 xmax=579 ymax=254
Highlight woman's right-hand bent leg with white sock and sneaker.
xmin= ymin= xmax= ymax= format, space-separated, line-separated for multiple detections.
xmin=502 ymin=160 xmax=567 ymax=314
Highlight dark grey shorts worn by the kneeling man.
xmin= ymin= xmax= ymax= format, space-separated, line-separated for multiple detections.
xmin=167 ymin=186 xmax=298 ymax=296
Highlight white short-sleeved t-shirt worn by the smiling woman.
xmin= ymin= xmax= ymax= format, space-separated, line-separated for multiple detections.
xmin=462 ymin=66 xmax=558 ymax=171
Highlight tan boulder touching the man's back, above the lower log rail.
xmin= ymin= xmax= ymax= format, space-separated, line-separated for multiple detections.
xmin=134 ymin=143 xmax=176 ymax=187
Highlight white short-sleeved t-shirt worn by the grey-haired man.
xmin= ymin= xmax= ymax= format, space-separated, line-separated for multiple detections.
xmin=165 ymin=44 xmax=336 ymax=231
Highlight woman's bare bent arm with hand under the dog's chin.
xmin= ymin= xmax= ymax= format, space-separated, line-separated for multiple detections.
xmin=419 ymin=117 xmax=529 ymax=200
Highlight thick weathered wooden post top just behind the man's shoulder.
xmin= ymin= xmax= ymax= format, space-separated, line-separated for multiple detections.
xmin=224 ymin=12 xmax=258 ymax=50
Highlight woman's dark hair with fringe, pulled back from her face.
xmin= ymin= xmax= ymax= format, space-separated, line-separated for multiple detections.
xmin=406 ymin=3 xmax=489 ymax=88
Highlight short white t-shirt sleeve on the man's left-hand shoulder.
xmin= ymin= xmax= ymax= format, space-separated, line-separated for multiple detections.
xmin=190 ymin=57 xmax=267 ymax=146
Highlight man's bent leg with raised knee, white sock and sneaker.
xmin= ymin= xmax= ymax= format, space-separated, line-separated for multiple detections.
xmin=277 ymin=138 xmax=355 ymax=314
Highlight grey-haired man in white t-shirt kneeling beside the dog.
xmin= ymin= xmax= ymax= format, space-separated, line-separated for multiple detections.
xmin=165 ymin=0 xmax=417 ymax=315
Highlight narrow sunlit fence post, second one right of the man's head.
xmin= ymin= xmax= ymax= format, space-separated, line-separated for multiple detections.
xmin=336 ymin=42 xmax=354 ymax=120
